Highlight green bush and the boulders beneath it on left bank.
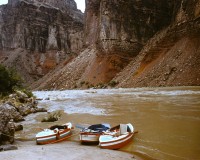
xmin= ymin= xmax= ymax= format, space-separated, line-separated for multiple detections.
xmin=0 ymin=65 xmax=46 ymax=146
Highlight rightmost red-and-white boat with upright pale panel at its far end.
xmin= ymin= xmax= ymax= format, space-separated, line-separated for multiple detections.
xmin=99 ymin=123 xmax=136 ymax=149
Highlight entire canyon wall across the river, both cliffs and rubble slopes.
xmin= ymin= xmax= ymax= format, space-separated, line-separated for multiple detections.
xmin=0 ymin=0 xmax=200 ymax=90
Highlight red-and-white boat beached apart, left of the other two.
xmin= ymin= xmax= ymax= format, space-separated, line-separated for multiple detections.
xmin=36 ymin=122 xmax=73 ymax=144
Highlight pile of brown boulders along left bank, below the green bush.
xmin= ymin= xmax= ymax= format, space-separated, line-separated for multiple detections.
xmin=0 ymin=91 xmax=47 ymax=151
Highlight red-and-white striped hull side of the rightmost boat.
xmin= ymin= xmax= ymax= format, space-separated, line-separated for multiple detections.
xmin=99 ymin=133 xmax=133 ymax=149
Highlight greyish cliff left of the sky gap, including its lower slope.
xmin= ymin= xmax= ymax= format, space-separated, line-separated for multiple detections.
xmin=0 ymin=0 xmax=83 ymax=83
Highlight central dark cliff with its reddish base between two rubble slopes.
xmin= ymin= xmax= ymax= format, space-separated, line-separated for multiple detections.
xmin=74 ymin=0 xmax=175 ymax=85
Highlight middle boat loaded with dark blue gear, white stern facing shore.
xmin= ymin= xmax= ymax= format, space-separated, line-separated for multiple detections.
xmin=79 ymin=124 xmax=110 ymax=144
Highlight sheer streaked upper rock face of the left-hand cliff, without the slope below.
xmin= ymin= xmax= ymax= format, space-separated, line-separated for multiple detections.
xmin=0 ymin=0 xmax=83 ymax=53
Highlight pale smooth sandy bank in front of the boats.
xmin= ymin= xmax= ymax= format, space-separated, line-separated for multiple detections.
xmin=0 ymin=141 xmax=138 ymax=160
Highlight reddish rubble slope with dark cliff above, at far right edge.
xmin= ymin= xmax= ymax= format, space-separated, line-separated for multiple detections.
xmin=114 ymin=0 xmax=200 ymax=87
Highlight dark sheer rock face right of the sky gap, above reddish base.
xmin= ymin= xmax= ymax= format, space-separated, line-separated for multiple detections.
xmin=86 ymin=0 xmax=174 ymax=56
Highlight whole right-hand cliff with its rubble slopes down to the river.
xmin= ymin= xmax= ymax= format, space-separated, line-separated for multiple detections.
xmin=31 ymin=0 xmax=200 ymax=89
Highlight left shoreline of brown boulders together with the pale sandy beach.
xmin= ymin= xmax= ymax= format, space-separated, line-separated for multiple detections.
xmin=0 ymin=91 xmax=138 ymax=160
